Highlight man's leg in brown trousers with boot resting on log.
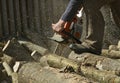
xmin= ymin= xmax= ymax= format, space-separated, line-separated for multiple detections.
xmin=71 ymin=0 xmax=106 ymax=54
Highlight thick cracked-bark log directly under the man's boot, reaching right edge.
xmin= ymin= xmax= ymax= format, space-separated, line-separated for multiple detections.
xmin=69 ymin=52 xmax=120 ymax=71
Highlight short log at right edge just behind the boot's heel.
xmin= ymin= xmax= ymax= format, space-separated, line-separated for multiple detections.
xmin=101 ymin=49 xmax=120 ymax=59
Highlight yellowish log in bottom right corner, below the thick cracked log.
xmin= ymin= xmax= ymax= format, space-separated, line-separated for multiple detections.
xmin=81 ymin=66 xmax=120 ymax=83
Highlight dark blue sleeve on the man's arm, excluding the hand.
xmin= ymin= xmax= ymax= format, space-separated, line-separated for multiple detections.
xmin=61 ymin=0 xmax=83 ymax=22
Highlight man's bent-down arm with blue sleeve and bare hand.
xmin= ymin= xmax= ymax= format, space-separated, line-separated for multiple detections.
xmin=52 ymin=0 xmax=83 ymax=33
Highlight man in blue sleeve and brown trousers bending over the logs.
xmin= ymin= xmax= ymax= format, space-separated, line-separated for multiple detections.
xmin=52 ymin=0 xmax=120 ymax=55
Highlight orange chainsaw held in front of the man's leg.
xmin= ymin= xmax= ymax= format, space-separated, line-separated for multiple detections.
xmin=50 ymin=18 xmax=81 ymax=44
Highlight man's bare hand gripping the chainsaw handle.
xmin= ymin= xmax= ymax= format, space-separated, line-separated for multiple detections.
xmin=52 ymin=19 xmax=65 ymax=33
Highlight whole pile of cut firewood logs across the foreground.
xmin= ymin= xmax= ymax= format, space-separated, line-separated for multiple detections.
xmin=0 ymin=39 xmax=120 ymax=83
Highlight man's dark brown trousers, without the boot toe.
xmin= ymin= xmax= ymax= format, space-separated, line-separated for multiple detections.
xmin=83 ymin=0 xmax=120 ymax=51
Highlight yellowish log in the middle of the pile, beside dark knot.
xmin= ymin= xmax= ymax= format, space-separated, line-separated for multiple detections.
xmin=46 ymin=54 xmax=80 ymax=72
